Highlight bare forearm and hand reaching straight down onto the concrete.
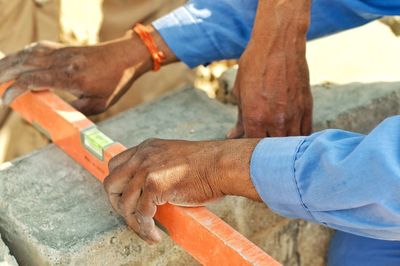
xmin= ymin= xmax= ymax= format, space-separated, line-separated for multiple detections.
xmin=228 ymin=0 xmax=312 ymax=138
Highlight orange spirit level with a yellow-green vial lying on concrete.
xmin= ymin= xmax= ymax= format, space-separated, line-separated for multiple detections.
xmin=0 ymin=81 xmax=281 ymax=266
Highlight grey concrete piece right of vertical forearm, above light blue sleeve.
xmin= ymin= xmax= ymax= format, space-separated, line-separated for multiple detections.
xmin=313 ymin=82 xmax=400 ymax=133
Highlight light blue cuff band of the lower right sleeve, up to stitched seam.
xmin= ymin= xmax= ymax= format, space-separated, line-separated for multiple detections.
xmin=250 ymin=137 xmax=315 ymax=221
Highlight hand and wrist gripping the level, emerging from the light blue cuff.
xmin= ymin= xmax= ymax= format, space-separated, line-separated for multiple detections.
xmin=104 ymin=139 xmax=261 ymax=243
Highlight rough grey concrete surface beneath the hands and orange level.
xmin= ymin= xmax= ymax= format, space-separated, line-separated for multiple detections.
xmin=0 ymin=83 xmax=400 ymax=265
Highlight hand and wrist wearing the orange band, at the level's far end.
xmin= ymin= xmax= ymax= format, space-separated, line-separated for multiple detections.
xmin=0 ymin=26 xmax=176 ymax=115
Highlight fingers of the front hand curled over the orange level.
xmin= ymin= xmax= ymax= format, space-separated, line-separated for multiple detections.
xmin=104 ymin=147 xmax=165 ymax=244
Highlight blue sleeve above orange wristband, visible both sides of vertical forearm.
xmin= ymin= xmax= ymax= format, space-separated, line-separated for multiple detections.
xmin=153 ymin=0 xmax=400 ymax=67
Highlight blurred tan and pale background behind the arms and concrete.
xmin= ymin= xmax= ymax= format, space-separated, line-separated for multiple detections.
xmin=0 ymin=0 xmax=400 ymax=162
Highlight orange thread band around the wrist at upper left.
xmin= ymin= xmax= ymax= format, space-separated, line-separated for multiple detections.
xmin=133 ymin=23 xmax=165 ymax=71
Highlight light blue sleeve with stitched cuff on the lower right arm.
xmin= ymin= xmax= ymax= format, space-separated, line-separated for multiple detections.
xmin=250 ymin=116 xmax=400 ymax=240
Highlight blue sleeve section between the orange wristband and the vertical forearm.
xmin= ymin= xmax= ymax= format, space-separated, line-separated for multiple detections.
xmin=153 ymin=0 xmax=258 ymax=67
